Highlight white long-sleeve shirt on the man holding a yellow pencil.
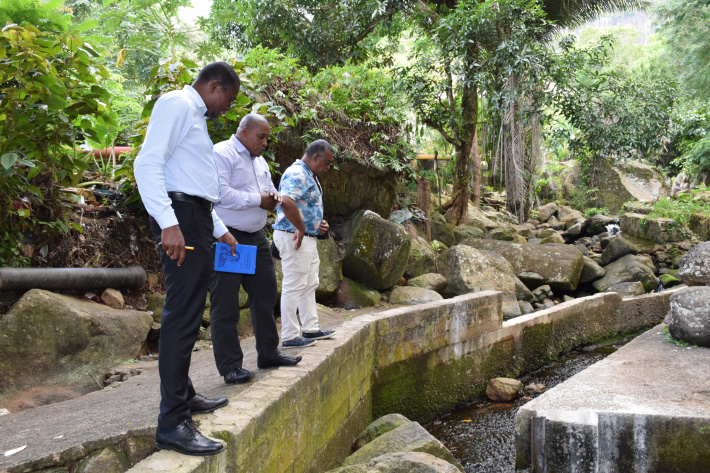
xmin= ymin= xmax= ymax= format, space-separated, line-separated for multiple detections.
xmin=134 ymin=85 xmax=227 ymax=238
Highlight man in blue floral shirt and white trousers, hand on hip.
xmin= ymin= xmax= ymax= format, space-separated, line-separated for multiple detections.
xmin=273 ymin=140 xmax=334 ymax=348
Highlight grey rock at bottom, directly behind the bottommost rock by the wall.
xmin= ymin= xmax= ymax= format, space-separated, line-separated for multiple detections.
xmin=343 ymin=422 xmax=464 ymax=471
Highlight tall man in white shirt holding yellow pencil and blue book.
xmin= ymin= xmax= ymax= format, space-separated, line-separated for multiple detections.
xmin=134 ymin=62 xmax=240 ymax=455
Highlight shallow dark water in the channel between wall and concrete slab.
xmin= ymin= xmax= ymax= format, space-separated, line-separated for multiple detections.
xmin=424 ymin=338 xmax=631 ymax=473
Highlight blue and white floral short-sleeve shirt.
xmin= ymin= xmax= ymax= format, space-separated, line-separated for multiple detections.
xmin=273 ymin=159 xmax=323 ymax=235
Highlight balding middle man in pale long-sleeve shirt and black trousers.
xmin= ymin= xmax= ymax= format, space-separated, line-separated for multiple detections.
xmin=210 ymin=113 xmax=301 ymax=383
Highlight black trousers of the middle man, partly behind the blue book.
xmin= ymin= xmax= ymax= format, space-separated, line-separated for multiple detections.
xmin=210 ymin=228 xmax=279 ymax=376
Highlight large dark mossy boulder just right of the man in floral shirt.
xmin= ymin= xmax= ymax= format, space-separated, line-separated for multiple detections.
xmin=343 ymin=210 xmax=412 ymax=290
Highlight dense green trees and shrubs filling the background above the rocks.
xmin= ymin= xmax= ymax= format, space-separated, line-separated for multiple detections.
xmin=0 ymin=0 xmax=710 ymax=265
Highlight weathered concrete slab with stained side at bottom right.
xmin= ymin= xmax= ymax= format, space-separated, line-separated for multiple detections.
xmin=515 ymin=325 xmax=710 ymax=473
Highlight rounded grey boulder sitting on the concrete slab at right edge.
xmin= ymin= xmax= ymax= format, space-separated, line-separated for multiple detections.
xmin=667 ymin=286 xmax=710 ymax=348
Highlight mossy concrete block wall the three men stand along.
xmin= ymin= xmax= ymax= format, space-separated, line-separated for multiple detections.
xmin=130 ymin=291 xmax=680 ymax=473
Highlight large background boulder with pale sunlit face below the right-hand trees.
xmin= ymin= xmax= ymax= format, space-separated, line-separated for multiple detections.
xmin=563 ymin=158 xmax=671 ymax=213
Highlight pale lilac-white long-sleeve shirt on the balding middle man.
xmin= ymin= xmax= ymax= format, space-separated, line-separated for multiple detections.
xmin=214 ymin=135 xmax=276 ymax=233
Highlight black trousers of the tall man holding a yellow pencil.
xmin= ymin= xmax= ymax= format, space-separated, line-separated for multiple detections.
xmin=150 ymin=201 xmax=213 ymax=430
